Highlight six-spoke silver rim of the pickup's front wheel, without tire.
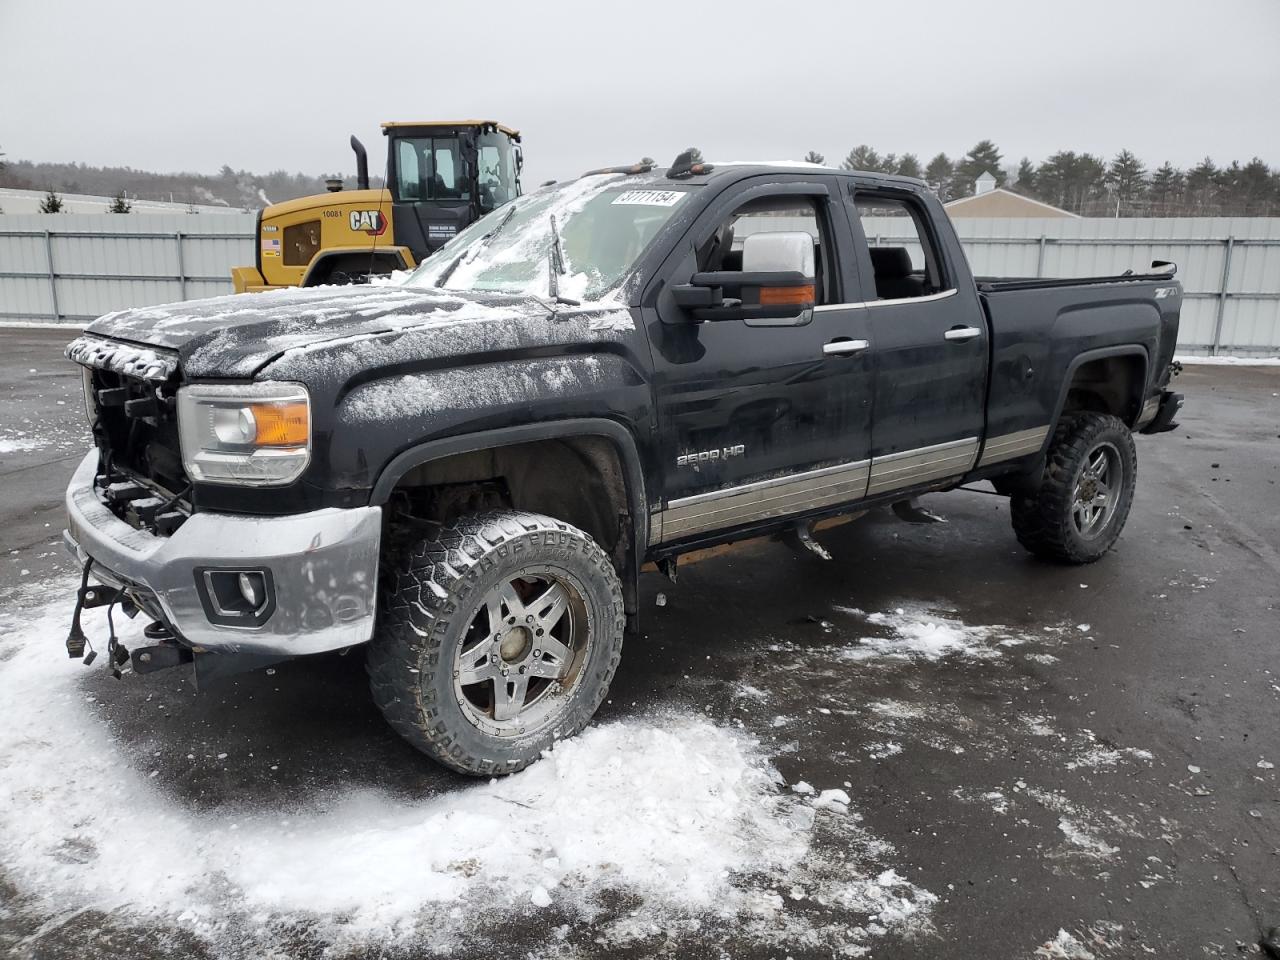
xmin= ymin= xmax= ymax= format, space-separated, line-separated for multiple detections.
xmin=453 ymin=568 xmax=593 ymax=736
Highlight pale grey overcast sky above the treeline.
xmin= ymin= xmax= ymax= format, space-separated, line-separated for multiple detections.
xmin=0 ymin=0 xmax=1280 ymax=183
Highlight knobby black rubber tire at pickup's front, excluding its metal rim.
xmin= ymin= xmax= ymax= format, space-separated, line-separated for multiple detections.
xmin=366 ymin=509 xmax=626 ymax=776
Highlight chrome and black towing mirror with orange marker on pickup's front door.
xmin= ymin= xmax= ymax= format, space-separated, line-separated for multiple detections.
xmin=671 ymin=232 xmax=815 ymax=326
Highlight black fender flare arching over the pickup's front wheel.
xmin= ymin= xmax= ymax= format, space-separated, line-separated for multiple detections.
xmin=369 ymin=417 xmax=649 ymax=576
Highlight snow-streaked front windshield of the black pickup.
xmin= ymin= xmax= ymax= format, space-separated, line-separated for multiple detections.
xmin=404 ymin=175 xmax=686 ymax=301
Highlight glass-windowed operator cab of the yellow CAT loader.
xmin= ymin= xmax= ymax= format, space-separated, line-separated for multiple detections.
xmin=383 ymin=120 xmax=522 ymax=260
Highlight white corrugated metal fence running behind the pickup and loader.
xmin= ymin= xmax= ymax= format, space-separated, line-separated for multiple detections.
xmin=0 ymin=214 xmax=1280 ymax=356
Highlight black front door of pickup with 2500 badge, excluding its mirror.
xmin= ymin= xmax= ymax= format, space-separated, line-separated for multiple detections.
xmin=645 ymin=175 xmax=874 ymax=543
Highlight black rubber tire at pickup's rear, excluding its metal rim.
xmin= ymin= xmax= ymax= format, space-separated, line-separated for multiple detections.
xmin=1010 ymin=413 xmax=1138 ymax=563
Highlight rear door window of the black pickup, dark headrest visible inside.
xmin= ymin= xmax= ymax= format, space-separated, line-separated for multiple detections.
xmin=854 ymin=191 xmax=946 ymax=300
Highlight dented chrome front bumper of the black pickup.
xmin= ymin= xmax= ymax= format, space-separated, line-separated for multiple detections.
xmin=63 ymin=451 xmax=381 ymax=657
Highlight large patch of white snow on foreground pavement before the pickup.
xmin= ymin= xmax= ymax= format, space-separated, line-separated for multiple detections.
xmin=0 ymin=582 xmax=936 ymax=955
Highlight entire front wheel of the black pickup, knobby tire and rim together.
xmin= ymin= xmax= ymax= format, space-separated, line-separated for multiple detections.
xmin=366 ymin=511 xmax=626 ymax=776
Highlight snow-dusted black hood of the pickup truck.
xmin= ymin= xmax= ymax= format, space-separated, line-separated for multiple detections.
xmin=86 ymin=285 xmax=630 ymax=378
